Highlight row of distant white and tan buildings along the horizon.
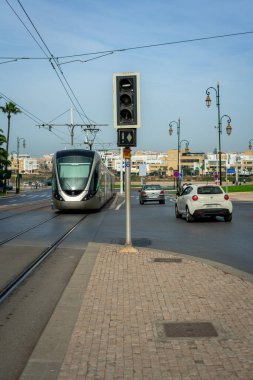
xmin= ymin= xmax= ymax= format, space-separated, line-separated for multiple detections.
xmin=6 ymin=149 xmax=253 ymax=177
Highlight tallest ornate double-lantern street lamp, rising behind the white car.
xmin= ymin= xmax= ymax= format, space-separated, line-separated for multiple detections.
xmin=206 ymin=82 xmax=232 ymax=185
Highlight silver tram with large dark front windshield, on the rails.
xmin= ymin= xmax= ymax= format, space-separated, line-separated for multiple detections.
xmin=52 ymin=149 xmax=114 ymax=210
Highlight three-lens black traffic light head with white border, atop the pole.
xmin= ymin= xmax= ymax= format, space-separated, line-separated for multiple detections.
xmin=113 ymin=73 xmax=140 ymax=128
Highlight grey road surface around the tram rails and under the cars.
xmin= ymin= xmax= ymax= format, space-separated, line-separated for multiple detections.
xmin=0 ymin=189 xmax=253 ymax=380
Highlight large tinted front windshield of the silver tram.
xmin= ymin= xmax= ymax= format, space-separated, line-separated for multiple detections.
xmin=57 ymin=156 xmax=92 ymax=191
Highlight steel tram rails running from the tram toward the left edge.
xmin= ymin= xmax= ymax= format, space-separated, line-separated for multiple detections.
xmin=0 ymin=215 xmax=88 ymax=304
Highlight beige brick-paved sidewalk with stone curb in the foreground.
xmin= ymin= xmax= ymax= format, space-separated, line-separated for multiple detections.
xmin=20 ymin=243 xmax=253 ymax=380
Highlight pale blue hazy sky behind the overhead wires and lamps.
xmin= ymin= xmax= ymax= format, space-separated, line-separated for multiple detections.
xmin=0 ymin=0 xmax=253 ymax=156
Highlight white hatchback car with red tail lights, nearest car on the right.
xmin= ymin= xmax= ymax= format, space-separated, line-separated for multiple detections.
xmin=175 ymin=185 xmax=233 ymax=223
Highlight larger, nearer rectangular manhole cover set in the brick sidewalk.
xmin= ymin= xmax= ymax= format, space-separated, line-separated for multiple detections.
xmin=163 ymin=322 xmax=218 ymax=338
